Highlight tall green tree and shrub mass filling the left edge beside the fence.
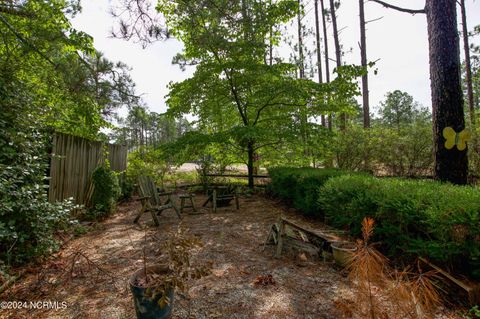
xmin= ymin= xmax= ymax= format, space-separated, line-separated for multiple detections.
xmin=0 ymin=0 xmax=136 ymax=263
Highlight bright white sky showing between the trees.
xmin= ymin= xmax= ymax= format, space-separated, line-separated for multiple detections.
xmin=72 ymin=0 xmax=480 ymax=117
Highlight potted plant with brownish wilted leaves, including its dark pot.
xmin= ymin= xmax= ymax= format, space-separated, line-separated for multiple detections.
xmin=130 ymin=227 xmax=210 ymax=319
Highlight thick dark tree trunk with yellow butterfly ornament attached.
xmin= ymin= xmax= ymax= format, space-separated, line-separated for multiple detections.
xmin=425 ymin=0 xmax=468 ymax=184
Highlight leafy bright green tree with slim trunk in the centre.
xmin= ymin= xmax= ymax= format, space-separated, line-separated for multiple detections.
xmin=157 ymin=0 xmax=360 ymax=187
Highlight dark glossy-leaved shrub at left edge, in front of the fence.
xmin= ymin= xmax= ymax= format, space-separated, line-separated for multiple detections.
xmin=0 ymin=114 xmax=73 ymax=264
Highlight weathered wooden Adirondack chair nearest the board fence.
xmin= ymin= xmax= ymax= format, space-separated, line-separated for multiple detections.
xmin=133 ymin=176 xmax=182 ymax=226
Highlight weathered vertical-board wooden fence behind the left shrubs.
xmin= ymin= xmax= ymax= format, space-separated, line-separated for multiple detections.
xmin=48 ymin=133 xmax=127 ymax=205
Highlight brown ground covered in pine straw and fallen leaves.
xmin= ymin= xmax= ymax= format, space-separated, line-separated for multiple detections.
xmin=0 ymin=195 xmax=464 ymax=319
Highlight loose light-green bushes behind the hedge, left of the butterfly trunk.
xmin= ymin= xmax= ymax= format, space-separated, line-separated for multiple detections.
xmin=325 ymin=121 xmax=433 ymax=176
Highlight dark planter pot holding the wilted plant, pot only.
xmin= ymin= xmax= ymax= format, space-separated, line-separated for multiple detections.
xmin=130 ymin=266 xmax=174 ymax=319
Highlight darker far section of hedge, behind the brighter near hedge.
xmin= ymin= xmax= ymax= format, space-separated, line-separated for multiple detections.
xmin=268 ymin=167 xmax=356 ymax=216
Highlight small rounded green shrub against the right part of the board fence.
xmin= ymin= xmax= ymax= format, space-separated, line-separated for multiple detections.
xmin=90 ymin=163 xmax=121 ymax=219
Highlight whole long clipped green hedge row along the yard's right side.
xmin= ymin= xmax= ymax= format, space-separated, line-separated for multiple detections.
xmin=271 ymin=168 xmax=480 ymax=278
